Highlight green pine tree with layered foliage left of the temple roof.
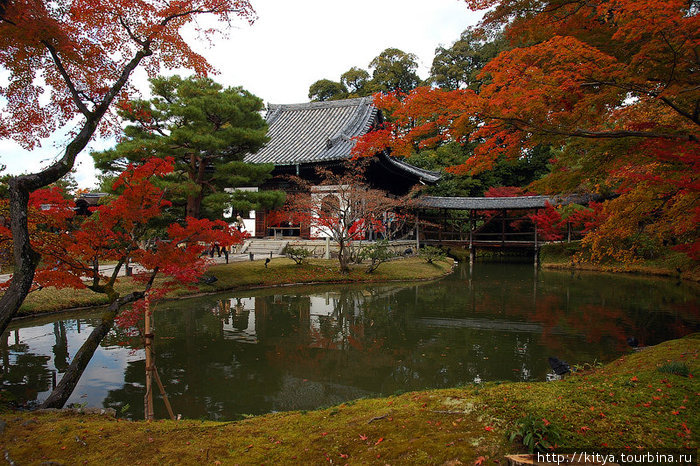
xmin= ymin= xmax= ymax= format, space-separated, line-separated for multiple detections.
xmin=92 ymin=76 xmax=283 ymax=219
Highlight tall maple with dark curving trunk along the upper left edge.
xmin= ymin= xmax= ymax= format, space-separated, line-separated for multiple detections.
xmin=0 ymin=0 xmax=255 ymax=332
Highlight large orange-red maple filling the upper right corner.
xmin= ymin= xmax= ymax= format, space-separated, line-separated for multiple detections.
xmin=356 ymin=0 xmax=700 ymax=261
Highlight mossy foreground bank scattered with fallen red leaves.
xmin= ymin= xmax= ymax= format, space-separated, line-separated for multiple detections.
xmin=0 ymin=335 xmax=700 ymax=464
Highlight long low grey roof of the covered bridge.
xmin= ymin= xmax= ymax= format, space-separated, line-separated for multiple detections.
xmin=417 ymin=196 xmax=590 ymax=210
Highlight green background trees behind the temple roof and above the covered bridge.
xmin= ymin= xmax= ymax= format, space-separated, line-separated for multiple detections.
xmin=309 ymin=34 xmax=552 ymax=196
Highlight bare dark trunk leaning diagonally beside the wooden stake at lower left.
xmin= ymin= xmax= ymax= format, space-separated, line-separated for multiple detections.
xmin=41 ymin=292 xmax=144 ymax=409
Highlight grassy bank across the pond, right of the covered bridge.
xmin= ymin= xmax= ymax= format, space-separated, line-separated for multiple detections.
xmin=540 ymin=242 xmax=700 ymax=282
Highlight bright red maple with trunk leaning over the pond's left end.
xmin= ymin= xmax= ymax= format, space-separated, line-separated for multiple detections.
xmin=0 ymin=158 xmax=242 ymax=408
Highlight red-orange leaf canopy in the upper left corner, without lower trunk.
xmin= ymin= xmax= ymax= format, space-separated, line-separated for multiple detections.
xmin=0 ymin=0 xmax=255 ymax=147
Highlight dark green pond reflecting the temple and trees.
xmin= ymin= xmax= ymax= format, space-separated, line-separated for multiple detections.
xmin=0 ymin=263 xmax=700 ymax=419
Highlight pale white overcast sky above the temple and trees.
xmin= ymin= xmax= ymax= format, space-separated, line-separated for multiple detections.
xmin=0 ymin=0 xmax=481 ymax=187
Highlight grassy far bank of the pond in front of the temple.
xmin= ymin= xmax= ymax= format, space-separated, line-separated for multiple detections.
xmin=12 ymin=257 xmax=452 ymax=316
